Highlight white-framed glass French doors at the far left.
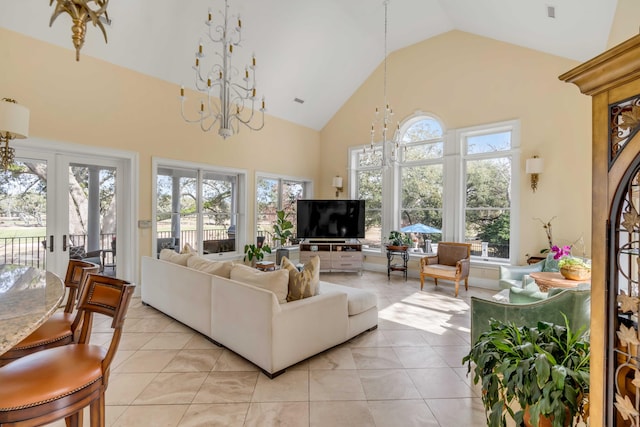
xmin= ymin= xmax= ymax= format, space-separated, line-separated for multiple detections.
xmin=0 ymin=142 xmax=134 ymax=280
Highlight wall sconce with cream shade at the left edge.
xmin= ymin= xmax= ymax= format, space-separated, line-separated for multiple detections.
xmin=0 ymin=98 xmax=29 ymax=169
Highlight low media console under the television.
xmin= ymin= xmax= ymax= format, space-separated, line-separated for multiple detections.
xmin=300 ymin=239 xmax=364 ymax=272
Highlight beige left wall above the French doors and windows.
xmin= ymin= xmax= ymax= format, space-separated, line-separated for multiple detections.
xmin=0 ymin=29 xmax=320 ymax=260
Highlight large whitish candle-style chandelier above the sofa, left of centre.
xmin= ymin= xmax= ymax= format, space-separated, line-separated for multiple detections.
xmin=180 ymin=0 xmax=266 ymax=139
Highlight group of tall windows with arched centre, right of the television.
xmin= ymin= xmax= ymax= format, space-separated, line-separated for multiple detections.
xmin=350 ymin=114 xmax=519 ymax=262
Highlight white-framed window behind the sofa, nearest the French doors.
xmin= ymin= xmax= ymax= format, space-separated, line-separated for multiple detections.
xmin=155 ymin=162 xmax=245 ymax=254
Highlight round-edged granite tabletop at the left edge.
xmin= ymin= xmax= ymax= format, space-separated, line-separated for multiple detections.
xmin=0 ymin=264 xmax=65 ymax=354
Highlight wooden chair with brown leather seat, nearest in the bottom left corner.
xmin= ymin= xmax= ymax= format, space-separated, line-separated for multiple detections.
xmin=0 ymin=274 xmax=135 ymax=427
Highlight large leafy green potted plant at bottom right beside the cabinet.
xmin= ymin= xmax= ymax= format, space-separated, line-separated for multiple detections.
xmin=462 ymin=316 xmax=590 ymax=427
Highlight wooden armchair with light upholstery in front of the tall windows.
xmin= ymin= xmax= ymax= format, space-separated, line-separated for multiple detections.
xmin=420 ymin=242 xmax=471 ymax=297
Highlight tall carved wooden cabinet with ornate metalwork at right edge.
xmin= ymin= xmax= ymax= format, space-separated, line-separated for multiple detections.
xmin=560 ymin=35 xmax=640 ymax=426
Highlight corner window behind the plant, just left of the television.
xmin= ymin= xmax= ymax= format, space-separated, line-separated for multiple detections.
xmin=256 ymin=176 xmax=310 ymax=247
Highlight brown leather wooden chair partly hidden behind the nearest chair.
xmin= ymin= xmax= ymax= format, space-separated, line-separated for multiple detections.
xmin=0 ymin=259 xmax=100 ymax=366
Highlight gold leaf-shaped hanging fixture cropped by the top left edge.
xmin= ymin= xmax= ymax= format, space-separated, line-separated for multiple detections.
xmin=49 ymin=0 xmax=111 ymax=61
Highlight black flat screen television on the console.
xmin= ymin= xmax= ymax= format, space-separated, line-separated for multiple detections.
xmin=297 ymin=200 xmax=364 ymax=239
